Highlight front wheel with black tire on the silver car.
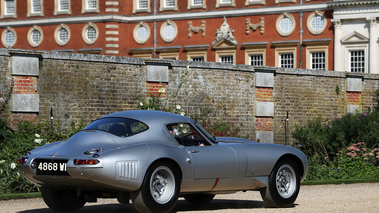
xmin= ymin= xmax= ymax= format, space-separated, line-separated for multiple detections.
xmin=260 ymin=159 xmax=300 ymax=208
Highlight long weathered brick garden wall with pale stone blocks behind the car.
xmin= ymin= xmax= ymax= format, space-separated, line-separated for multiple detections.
xmin=0 ymin=49 xmax=379 ymax=143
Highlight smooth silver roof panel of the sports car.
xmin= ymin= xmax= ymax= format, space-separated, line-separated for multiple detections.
xmin=102 ymin=110 xmax=194 ymax=125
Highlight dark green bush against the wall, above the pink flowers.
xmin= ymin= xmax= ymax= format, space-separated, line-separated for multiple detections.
xmin=292 ymin=112 xmax=379 ymax=158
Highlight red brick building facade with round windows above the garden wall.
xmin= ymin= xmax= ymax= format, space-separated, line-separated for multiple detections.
xmin=0 ymin=0 xmax=334 ymax=70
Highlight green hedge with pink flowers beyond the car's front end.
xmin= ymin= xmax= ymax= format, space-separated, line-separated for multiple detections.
xmin=292 ymin=111 xmax=379 ymax=180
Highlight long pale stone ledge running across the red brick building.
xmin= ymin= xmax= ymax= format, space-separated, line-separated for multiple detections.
xmin=0 ymin=3 xmax=331 ymax=28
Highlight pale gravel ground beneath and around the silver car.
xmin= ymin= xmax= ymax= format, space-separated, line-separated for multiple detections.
xmin=0 ymin=183 xmax=379 ymax=213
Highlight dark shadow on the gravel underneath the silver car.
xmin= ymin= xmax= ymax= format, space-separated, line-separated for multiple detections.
xmin=20 ymin=199 xmax=264 ymax=213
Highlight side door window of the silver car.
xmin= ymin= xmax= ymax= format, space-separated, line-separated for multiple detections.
xmin=166 ymin=123 xmax=210 ymax=146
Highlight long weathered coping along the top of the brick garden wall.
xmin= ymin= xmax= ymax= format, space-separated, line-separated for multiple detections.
xmin=0 ymin=48 xmax=379 ymax=80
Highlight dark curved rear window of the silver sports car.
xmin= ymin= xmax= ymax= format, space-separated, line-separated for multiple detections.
xmin=84 ymin=118 xmax=149 ymax=137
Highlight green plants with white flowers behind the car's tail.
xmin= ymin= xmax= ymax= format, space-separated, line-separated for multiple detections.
xmin=0 ymin=120 xmax=84 ymax=193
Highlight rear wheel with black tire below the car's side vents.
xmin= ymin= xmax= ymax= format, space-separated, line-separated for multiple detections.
xmin=130 ymin=162 xmax=180 ymax=213
